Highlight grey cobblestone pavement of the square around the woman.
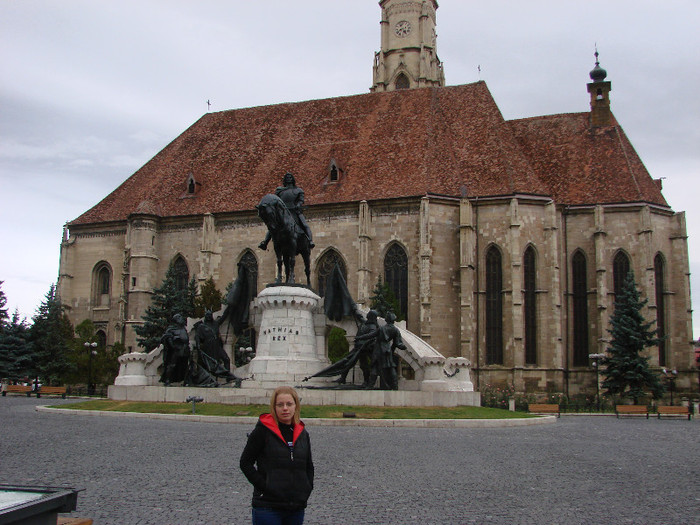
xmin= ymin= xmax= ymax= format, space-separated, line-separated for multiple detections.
xmin=0 ymin=396 xmax=700 ymax=525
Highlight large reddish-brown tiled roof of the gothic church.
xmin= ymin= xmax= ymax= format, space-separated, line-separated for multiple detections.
xmin=71 ymin=82 xmax=665 ymax=225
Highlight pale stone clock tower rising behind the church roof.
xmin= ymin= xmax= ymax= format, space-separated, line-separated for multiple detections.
xmin=370 ymin=0 xmax=445 ymax=92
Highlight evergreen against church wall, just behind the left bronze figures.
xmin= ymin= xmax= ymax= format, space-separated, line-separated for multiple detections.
xmin=135 ymin=265 xmax=197 ymax=352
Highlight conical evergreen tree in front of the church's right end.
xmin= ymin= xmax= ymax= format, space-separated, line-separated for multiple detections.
xmin=601 ymin=272 xmax=664 ymax=405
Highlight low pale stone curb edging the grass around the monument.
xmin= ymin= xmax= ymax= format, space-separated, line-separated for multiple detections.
xmin=36 ymin=406 xmax=557 ymax=428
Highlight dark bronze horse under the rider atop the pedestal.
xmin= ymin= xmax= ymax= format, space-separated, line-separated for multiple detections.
xmin=256 ymin=193 xmax=311 ymax=287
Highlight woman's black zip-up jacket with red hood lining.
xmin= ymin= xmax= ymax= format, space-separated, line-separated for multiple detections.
xmin=240 ymin=414 xmax=314 ymax=510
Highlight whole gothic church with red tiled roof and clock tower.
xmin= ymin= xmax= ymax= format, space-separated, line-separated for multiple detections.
xmin=59 ymin=0 xmax=696 ymax=395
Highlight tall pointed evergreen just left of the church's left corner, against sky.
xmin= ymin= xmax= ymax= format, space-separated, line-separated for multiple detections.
xmin=29 ymin=284 xmax=73 ymax=385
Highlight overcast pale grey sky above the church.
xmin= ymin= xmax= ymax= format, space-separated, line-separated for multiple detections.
xmin=0 ymin=0 xmax=700 ymax=337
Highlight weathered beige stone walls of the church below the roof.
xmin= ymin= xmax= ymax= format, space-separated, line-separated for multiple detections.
xmin=59 ymin=191 xmax=693 ymax=394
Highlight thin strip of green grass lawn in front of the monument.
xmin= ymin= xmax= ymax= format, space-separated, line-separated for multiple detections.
xmin=53 ymin=399 xmax=537 ymax=419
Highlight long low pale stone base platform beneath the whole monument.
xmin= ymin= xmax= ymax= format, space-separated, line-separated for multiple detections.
xmin=107 ymin=382 xmax=481 ymax=407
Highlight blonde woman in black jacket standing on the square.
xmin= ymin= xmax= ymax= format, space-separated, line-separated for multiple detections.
xmin=240 ymin=386 xmax=314 ymax=525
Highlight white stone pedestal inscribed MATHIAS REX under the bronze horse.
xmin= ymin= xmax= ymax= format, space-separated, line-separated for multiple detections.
xmin=242 ymin=286 xmax=329 ymax=388
